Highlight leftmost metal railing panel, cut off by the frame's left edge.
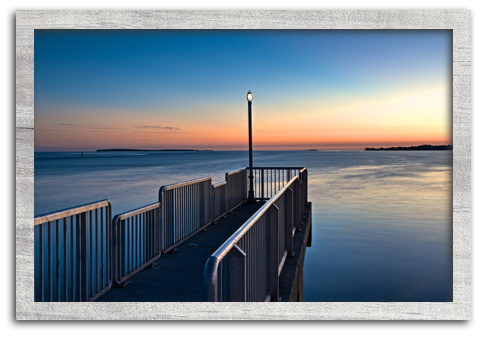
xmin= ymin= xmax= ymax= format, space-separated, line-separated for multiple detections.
xmin=34 ymin=200 xmax=112 ymax=302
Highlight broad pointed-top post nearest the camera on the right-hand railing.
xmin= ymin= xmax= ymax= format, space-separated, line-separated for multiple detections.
xmin=228 ymin=245 xmax=247 ymax=302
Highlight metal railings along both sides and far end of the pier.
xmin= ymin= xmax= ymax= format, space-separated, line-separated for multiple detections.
xmin=35 ymin=168 xmax=308 ymax=301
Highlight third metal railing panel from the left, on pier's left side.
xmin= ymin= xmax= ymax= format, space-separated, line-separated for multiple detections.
xmin=158 ymin=177 xmax=212 ymax=253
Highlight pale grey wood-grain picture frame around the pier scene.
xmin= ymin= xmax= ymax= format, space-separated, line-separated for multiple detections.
xmin=16 ymin=10 xmax=472 ymax=320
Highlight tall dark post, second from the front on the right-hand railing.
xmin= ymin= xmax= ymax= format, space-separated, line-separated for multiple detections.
xmin=268 ymin=204 xmax=279 ymax=301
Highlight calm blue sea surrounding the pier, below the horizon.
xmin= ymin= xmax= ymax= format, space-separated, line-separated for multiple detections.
xmin=35 ymin=151 xmax=452 ymax=302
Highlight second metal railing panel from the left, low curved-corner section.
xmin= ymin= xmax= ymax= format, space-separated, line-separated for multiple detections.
xmin=112 ymin=203 xmax=162 ymax=286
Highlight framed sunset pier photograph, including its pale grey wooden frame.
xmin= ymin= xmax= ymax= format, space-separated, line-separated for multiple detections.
xmin=16 ymin=10 xmax=471 ymax=320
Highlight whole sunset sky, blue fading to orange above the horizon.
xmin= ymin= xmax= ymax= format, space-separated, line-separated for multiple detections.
xmin=35 ymin=30 xmax=452 ymax=151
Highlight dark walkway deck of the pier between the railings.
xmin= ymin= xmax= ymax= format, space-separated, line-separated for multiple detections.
xmin=96 ymin=203 xmax=263 ymax=302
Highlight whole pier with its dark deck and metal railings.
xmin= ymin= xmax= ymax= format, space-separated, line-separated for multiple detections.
xmin=34 ymin=167 xmax=312 ymax=302
